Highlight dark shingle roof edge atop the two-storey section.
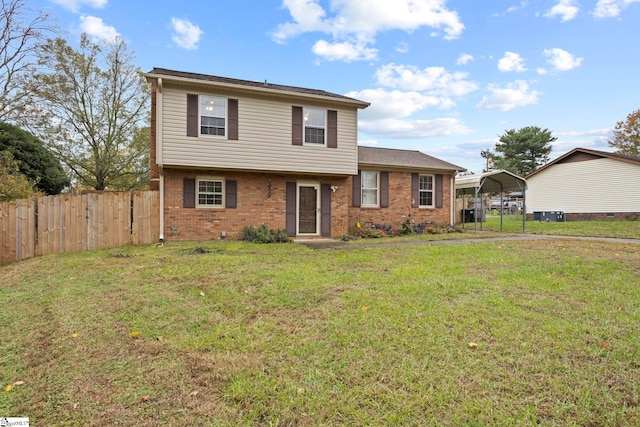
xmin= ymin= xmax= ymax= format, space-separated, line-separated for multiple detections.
xmin=145 ymin=68 xmax=369 ymax=108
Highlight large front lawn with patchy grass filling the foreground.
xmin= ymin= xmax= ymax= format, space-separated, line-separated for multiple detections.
xmin=0 ymin=239 xmax=640 ymax=426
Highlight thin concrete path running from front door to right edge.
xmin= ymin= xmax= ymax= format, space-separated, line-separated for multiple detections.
xmin=294 ymin=234 xmax=640 ymax=249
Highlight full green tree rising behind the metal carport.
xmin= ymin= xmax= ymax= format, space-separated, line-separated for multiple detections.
xmin=492 ymin=126 xmax=558 ymax=176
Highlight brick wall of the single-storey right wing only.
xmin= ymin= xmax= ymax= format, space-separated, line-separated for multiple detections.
xmin=349 ymin=172 xmax=451 ymax=234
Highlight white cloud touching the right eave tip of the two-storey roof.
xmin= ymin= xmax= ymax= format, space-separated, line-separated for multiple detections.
xmin=346 ymin=89 xmax=453 ymax=120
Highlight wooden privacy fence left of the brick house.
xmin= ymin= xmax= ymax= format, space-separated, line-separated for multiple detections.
xmin=0 ymin=191 xmax=160 ymax=264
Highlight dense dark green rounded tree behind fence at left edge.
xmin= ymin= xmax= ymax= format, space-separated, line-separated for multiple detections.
xmin=0 ymin=122 xmax=70 ymax=194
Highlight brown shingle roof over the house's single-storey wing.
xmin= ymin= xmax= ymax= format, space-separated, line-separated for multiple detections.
xmin=358 ymin=146 xmax=466 ymax=172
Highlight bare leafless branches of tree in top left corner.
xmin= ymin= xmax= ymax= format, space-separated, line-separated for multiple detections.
xmin=0 ymin=0 xmax=55 ymax=121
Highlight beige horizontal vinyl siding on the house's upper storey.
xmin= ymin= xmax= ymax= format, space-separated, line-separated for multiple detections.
xmin=162 ymin=87 xmax=357 ymax=175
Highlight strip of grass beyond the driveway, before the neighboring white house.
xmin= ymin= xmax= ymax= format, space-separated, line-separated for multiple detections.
xmin=464 ymin=215 xmax=640 ymax=239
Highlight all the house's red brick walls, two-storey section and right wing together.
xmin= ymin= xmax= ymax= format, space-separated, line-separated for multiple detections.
xmin=164 ymin=169 xmax=458 ymax=240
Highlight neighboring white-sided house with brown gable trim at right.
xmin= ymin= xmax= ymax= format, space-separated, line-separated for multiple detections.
xmin=526 ymin=148 xmax=640 ymax=221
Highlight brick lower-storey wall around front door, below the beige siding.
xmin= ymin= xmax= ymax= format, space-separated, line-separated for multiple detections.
xmin=164 ymin=169 xmax=351 ymax=240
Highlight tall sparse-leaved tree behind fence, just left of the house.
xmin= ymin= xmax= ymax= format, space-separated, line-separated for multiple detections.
xmin=30 ymin=34 xmax=149 ymax=190
